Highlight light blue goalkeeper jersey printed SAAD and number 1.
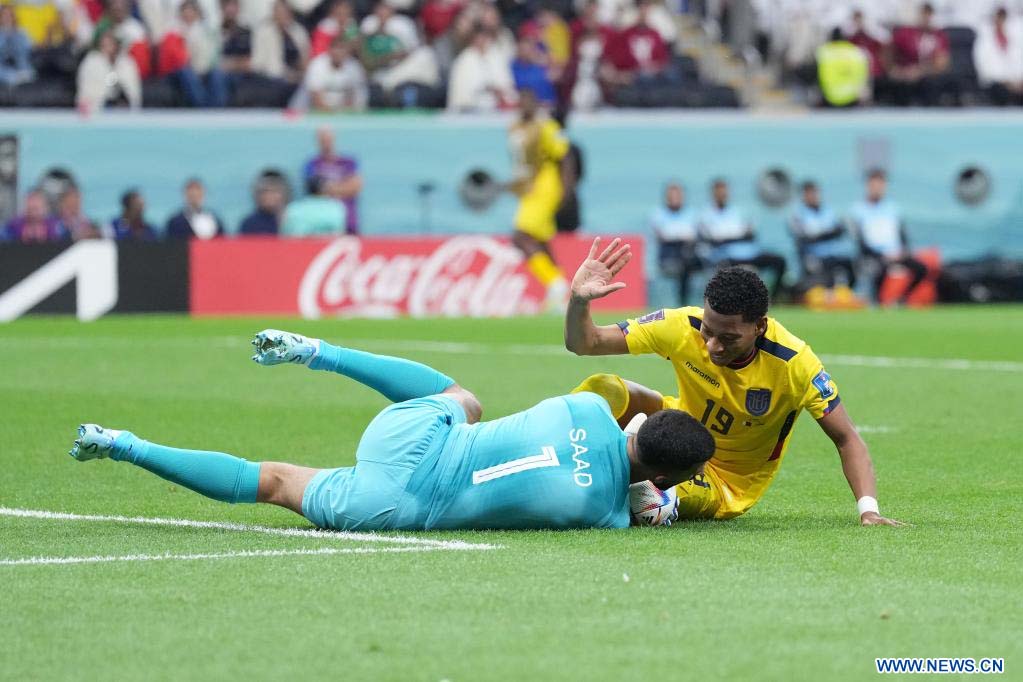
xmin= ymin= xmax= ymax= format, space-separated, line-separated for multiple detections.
xmin=397 ymin=393 xmax=629 ymax=529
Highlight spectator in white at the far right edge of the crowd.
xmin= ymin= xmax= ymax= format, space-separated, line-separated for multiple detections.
xmin=973 ymin=7 xmax=1023 ymax=105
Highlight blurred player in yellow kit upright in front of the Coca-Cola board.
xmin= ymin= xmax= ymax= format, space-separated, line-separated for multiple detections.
xmin=508 ymin=90 xmax=569 ymax=310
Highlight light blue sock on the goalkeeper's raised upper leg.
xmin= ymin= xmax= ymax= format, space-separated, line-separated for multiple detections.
xmin=309 ymin=340 xmax=454 ymax=403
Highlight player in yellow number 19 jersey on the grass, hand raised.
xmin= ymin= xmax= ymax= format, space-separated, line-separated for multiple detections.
xmin=565 ymin=238 xmax=901 ymax=526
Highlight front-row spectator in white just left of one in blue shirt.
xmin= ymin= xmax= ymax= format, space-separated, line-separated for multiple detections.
xmin=447 ymin=25 xmax=517 ymax=111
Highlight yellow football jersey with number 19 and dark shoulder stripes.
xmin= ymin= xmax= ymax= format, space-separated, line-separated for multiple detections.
xmin=619 ymin=308 xmax=840 ymax=518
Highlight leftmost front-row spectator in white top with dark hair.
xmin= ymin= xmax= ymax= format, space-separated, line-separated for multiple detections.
xmin=77 ymin=31 xmax=142 ymax=112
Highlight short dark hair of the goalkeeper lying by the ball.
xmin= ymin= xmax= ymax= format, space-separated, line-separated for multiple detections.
xmin=636 ymin=410 xmax=714 ymax=472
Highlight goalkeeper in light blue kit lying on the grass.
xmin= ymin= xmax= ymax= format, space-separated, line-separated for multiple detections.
xmin=71 ymin=329 xmax=714 ymax=531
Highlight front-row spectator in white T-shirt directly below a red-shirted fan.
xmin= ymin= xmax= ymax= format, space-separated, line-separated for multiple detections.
xmin=292 ymin=35 xmax=369 ymax=111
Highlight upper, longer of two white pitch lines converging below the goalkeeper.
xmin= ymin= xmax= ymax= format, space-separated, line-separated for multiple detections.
xmin=0 ymin=507 xmax=501 ymax=550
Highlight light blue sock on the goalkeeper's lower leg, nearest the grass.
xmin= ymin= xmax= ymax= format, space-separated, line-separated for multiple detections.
xmin=110 ymin=431 xmax=259 ymax=504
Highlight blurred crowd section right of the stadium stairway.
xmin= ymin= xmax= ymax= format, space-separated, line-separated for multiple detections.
xmin=736 ymin=0 xmax=1023 ymax=106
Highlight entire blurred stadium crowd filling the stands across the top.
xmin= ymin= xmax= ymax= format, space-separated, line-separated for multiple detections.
xmin=0 ymin=0 xmax=1023 ymax=112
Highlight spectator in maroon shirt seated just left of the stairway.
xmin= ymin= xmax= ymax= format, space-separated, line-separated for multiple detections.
xmin=601 ymin=0 xmax=672 ymax=90
